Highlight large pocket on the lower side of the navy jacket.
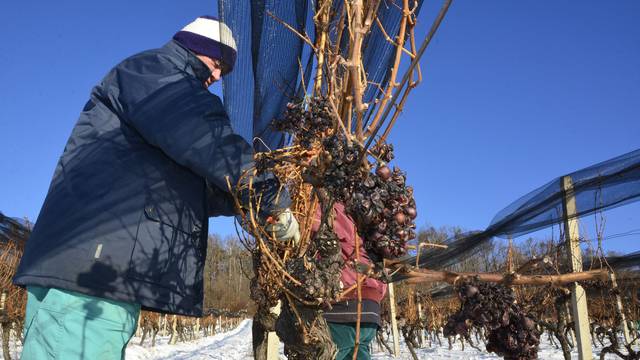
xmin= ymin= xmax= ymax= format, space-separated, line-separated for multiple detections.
xmin=128 ymin=206 xmax=204 ymax=294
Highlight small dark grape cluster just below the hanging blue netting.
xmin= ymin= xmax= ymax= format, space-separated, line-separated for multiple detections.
xmin=273 ymin=97 xmax=333 ymax=149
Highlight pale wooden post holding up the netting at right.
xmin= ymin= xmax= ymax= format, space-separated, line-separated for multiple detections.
xmin=560 ymin=176 xmax=593 ymax=360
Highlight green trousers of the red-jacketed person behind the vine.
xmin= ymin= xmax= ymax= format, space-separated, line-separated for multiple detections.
xmin=328 ymin=322 xmax=378 ymax=360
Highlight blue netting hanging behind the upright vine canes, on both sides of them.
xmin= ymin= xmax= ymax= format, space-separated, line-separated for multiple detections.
xmin=218 ymin=0 xmax=422 ymax=151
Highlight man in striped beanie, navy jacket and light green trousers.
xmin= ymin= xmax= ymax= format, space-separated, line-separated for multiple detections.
xmin=14 ymin=17 xmax=297 ymax=360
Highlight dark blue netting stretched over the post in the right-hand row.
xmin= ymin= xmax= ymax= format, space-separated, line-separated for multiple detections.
xmin=402 ymin=150 xmax=640 ymax=269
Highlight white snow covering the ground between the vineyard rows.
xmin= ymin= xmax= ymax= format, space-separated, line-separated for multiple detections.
xmin=0 ymin=320 xmax=632 ymax=360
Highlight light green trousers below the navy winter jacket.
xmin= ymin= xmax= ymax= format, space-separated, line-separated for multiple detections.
xmin=21 ymin=286 xmax=140 ymax=360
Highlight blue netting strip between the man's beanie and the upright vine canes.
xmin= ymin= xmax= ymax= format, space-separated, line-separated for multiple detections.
xmin=218 ymin=0 xmax=307 ymax=150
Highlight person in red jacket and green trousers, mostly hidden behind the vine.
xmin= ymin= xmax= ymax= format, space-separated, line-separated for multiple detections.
xmin=312 ymin=203 xmax=387 ymax=360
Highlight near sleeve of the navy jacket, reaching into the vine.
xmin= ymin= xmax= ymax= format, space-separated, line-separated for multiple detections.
xmin=114 ymin=77 xmax=289 ymax=214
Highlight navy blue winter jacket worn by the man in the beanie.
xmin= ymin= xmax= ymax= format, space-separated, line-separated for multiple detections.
xmin=14 ymin=41 xmax=288 ymax=315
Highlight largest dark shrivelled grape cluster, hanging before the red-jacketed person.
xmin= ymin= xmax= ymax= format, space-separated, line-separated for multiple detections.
xmin=322 ymin=136 xmax=417 ymax=258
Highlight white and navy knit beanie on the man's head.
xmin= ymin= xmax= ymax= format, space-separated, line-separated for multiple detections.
xmin=173 ymin=16 xmax=237 ymax=75
